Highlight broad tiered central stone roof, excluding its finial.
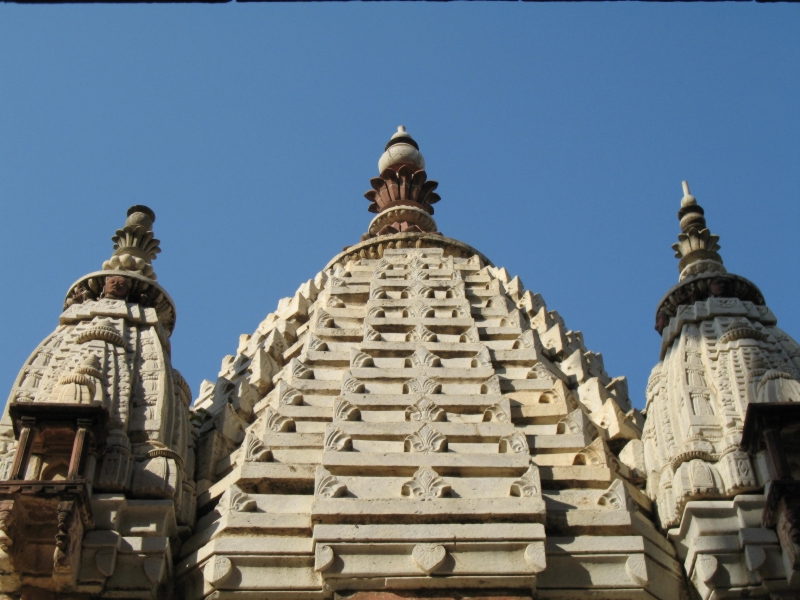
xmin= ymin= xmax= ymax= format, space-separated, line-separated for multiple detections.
xmin=183 ymin=245 xmax=682 ymax=600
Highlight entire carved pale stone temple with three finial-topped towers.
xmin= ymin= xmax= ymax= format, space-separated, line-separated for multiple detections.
xmin=0 ymin=127 xmax=800 ymax=600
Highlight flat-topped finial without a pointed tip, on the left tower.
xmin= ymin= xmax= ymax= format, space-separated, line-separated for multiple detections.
xmin=103 ymin=205 xmax=161 ymax=281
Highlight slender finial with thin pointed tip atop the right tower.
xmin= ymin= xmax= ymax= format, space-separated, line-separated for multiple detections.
xmin=672 ymin=181 xmax=726 ymax=280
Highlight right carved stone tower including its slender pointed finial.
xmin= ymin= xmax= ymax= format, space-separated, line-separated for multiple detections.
xmin=642 ymin=182 xmax=800 ymax=598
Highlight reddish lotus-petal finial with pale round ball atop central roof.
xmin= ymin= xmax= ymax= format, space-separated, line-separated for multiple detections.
xmin=364 ymin=125 xmax=441 ymax=237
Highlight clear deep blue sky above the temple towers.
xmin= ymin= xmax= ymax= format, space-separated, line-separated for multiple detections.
xmin=0 ymin=2 xmax=800 ymax=408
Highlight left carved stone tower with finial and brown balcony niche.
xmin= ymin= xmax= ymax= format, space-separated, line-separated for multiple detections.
xmin=0 ymin=206 xmax=195 ymax=600
